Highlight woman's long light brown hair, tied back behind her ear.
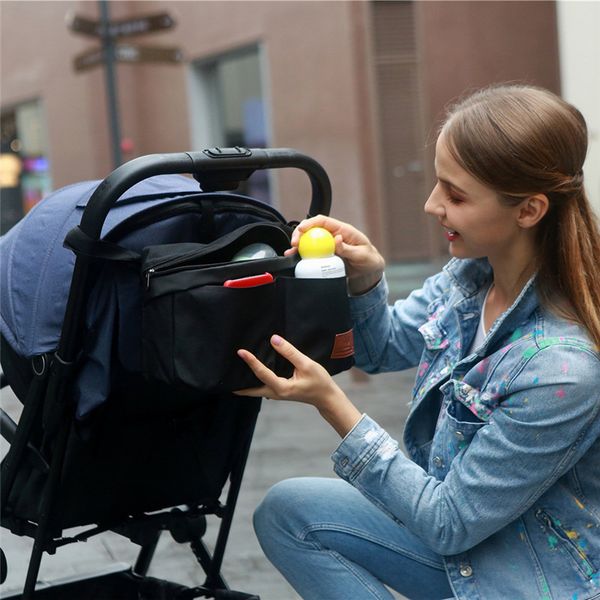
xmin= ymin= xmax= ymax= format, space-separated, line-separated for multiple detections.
xmin=442 ymin=84 xmax=600 ymax=347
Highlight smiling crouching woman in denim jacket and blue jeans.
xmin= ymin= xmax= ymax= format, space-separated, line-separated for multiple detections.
xmin=234 ymin=86 xmax=600 ymax=600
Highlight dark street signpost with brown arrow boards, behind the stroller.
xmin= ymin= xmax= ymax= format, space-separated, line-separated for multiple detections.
xmin=67 ymin=0 xmax=183 ymax=167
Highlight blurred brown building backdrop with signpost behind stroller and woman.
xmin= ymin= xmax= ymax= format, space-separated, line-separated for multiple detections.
xmin=0 ymin=0 xmax=600 ymax=251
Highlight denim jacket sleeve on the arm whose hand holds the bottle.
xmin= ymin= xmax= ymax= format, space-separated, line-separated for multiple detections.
xmin=350 ymin=271 xmax=450 ymax=373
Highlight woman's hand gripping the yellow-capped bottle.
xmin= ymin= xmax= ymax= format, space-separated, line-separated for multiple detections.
xmin=292 ymin=215 xmax=385 ymax=295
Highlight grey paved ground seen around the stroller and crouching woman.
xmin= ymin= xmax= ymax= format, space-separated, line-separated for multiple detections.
xmin=0 ymin=265 xmax=434 ymax=600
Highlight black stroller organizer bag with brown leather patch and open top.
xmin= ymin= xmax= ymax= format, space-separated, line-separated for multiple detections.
xmin=142 ymin=223 xmax=353 ymax=393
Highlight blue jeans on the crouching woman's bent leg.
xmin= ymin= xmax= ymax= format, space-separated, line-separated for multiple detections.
xmin=254 ymin=478 xmax=453 ymax=600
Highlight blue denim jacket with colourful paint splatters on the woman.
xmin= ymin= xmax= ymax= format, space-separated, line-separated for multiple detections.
xmin=332 ymin=259 xmax=600 ymax=600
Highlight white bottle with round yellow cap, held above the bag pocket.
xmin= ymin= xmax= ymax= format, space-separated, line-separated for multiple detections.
xmin=294 ymin=227 xmax=346 ymax=279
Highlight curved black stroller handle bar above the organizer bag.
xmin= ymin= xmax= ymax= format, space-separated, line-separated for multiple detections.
xmin=80 ymin=147 xmax=331 ymax=239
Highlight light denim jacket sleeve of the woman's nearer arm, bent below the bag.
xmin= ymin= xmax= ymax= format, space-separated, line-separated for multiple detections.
xmin=332 ymin=345 xmax=600 ymax=555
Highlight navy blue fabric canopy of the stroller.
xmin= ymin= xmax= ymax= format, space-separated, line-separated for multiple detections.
xmin=0 ymin=175 xmax=200 ymax=358
